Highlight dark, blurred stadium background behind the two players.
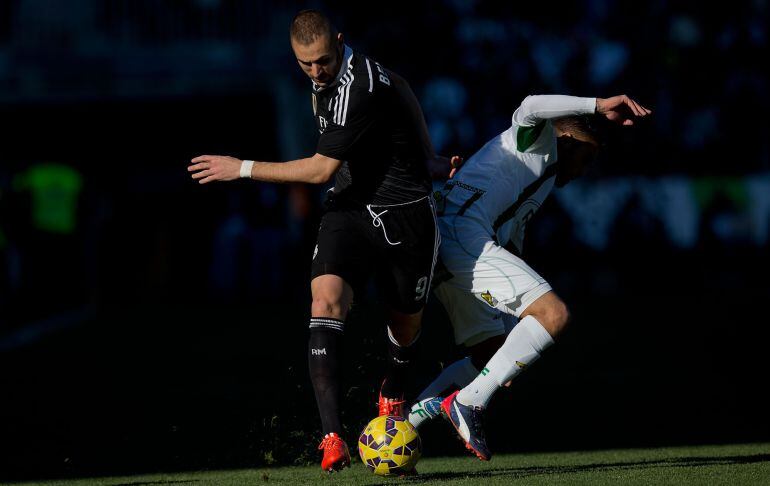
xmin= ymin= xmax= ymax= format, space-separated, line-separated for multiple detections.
xmin=0 ymin=0 xmax=770 ymax=479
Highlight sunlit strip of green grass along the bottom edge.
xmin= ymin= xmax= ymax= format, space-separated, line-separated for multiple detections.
xmin=12 ymin=444 xmax=770 ymax=486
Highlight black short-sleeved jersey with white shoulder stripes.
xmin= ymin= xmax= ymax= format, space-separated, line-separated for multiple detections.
xmin=313 ymin=46 xmax=431 ymax=205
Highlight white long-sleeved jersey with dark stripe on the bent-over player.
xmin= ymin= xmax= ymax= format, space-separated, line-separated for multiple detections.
xmin=442 ymin=95 xmax=596 ymax=253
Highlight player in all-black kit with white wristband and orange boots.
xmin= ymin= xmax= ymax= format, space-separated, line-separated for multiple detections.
xmin=189 ymin=10 xmax=440 ymax=471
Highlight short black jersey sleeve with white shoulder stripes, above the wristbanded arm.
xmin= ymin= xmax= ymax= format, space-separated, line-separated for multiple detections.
xmin=316 ymin=80 xmax=379 ymax=160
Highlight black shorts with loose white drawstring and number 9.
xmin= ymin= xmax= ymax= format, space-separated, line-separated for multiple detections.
xmin=311 ymin=196 xmax=441 ymax=314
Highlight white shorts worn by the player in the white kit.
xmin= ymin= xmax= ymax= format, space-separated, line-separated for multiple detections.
xmin=434 ymin=217 xmax=551 ymax=346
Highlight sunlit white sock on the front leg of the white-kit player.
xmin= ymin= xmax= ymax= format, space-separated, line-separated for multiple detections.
xmin=457 ymin=316 xmax=553 ymax=407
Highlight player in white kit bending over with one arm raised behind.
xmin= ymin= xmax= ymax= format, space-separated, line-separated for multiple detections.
xmin=409 ymin=95 xmax=651 ymax=460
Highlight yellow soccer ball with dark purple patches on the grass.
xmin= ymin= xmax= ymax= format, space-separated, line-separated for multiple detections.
xmin=358 ymin=415 xmax=422 ymax=476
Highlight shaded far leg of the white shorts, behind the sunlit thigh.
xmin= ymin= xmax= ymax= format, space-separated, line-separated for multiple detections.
xmin=433 ymin=282 xmax=506 ymax=347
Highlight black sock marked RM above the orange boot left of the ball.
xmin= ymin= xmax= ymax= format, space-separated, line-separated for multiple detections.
xmin=308 ymin=317 xmax=344 ymax=435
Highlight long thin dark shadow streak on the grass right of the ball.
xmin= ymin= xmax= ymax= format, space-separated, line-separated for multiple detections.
xmin=407 ymin=454 xmax=770 ymax=484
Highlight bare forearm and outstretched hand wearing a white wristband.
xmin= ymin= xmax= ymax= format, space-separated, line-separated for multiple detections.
xmin=187 ymin=154 xmax=342 ymax=184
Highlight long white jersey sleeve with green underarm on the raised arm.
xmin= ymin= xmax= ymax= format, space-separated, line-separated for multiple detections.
xmin=512 ymin=95 xmax=596 ymax=152
